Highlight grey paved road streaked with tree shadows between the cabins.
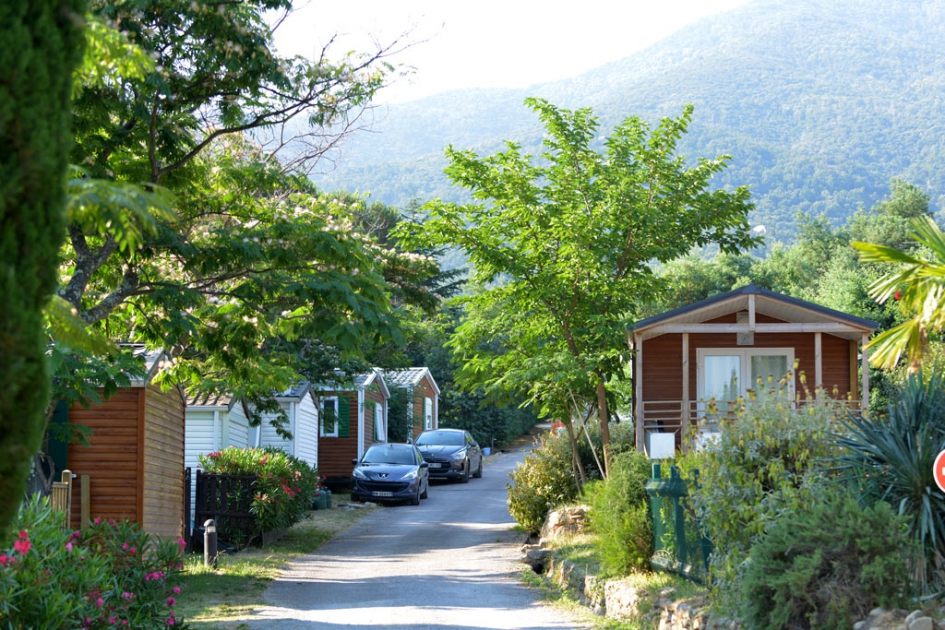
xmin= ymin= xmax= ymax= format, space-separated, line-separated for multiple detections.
xmin=244 ymin=452 xmax=585 ymax=630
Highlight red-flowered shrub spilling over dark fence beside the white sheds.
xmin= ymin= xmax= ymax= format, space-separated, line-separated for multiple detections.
xmin=200 ymin=447 xmax=319 ymax=534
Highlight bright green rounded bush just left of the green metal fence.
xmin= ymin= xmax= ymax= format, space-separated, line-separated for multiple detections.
xmin=584 ymin=451 xmax=653 ymax=576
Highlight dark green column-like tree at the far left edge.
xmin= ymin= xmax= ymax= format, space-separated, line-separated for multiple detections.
xmin=0 ymin=0 xmax=84 ymax=529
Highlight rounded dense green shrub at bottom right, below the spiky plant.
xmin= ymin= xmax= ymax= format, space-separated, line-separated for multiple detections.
xmin=741 ymin=488 xmax=909 ymax=630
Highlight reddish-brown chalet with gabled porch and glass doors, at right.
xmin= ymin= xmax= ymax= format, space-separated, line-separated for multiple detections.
xmin=631 ymin=285 xmax=879 ymax=457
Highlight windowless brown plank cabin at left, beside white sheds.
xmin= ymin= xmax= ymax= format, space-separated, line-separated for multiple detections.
xmin=68 ymin=347 xmax=184 ymax=538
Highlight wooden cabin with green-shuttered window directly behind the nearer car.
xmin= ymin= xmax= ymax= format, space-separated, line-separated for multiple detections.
xmin=315 ymin=369 xmax=390 ymax=487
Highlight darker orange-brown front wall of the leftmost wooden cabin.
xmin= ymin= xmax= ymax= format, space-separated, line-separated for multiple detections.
xmin=69 ymin=387 xmax=144 ymax=524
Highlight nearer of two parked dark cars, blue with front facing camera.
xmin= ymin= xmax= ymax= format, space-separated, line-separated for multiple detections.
xmin=351 ymin=444 xmax=430 ymax=505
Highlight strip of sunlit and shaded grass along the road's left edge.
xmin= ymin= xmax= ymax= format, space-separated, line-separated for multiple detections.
xmin=175 ymin=494 xmax=376 ymax=630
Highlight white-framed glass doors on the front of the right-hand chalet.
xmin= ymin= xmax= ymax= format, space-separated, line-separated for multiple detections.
xmin=696 ymin=348 xmax=794 ymax=401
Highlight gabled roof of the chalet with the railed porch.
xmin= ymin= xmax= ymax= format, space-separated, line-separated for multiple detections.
xmin=633 ymin=284 xmax=879 ymax=340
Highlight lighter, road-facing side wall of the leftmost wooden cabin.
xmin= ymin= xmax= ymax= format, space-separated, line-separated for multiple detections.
xmin=139 ymin=385 xmax=185 ymax=538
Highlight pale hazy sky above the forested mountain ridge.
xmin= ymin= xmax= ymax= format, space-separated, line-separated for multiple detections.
xmin=276 ymin=0 xmax=748 ymax=102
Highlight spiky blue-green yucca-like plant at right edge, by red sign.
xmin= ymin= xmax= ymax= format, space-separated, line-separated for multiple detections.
xmin=836 ymin=371 xmax=945 ymax=592
